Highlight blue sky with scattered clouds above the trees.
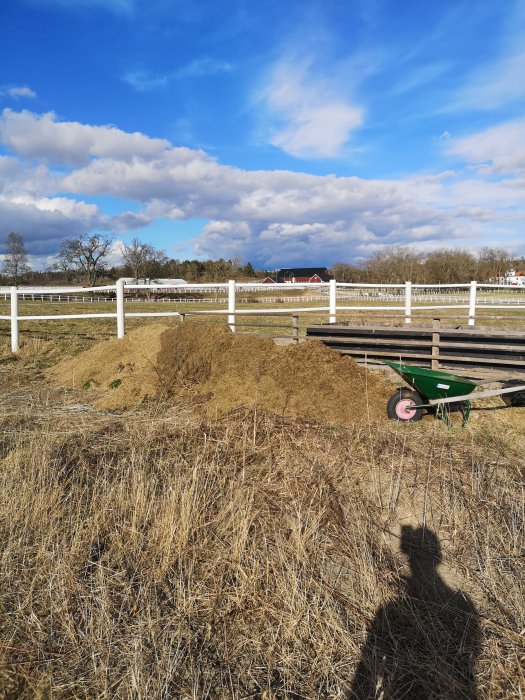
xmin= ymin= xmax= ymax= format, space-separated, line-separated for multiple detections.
xmin=0 ymin=0 xmax=525 ymax=269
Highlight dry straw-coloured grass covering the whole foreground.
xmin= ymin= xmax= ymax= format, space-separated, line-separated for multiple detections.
xmin=0 ymin=321 xmax=525 ymax=700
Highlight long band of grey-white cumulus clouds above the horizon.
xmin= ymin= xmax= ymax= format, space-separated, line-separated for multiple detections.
xmin=0 ymin=110 xmax=525 ymax=267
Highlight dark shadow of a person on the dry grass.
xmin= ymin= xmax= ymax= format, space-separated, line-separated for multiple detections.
xmin=349 ymin=526 xmax=480 ymax=700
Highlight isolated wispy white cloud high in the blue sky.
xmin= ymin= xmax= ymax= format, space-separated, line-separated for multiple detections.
xmin=258 ymin=59 xmax=363 ymax=158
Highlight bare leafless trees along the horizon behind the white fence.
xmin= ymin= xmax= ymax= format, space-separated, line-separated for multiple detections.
xmin=1 ymin=232 xmax=525 ymax=287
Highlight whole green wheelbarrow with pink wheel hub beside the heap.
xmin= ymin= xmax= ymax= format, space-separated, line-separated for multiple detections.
xmin=385 ymin=362 xmax=525 ymax=426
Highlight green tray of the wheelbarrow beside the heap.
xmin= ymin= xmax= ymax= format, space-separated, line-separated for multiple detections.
xmin=385 ymin=362 xmax=479 ymax=401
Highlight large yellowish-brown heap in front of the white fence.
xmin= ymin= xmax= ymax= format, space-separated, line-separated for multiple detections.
xmin=51 ymin=323 xmax=391 ymax=424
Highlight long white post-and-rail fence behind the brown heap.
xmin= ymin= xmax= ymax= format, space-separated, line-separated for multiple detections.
xmin=0 ymin=279 xmax=525 ymax=352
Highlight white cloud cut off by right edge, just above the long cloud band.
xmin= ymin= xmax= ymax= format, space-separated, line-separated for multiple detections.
xmin=447 ymin=117 xmax=525 ymax=173
